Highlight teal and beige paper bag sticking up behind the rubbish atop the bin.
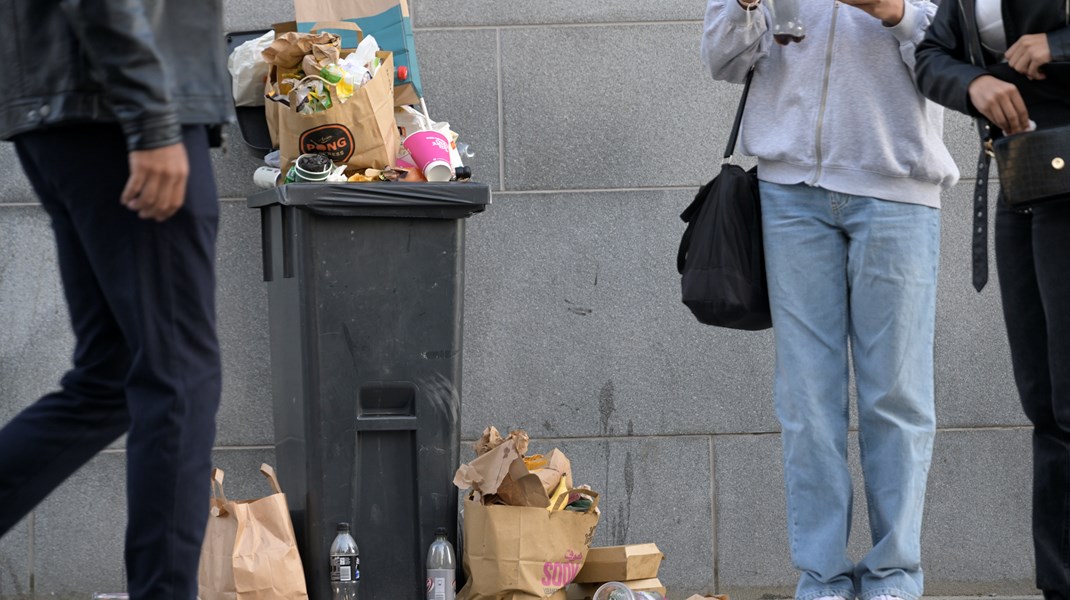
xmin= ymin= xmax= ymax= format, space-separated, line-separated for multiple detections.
xmin=293 ymin=0 xmax=424 ymax=106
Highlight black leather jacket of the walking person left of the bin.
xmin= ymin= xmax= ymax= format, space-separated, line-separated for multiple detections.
xmin=0 ymin=0 xmax=233 ymax=150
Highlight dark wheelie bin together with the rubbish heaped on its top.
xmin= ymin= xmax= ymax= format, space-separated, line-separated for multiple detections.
xmin=227 ymin=5 xmax=490 ymax=600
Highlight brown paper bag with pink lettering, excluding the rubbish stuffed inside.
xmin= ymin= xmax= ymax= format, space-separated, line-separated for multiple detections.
xmin=457 ymin=490 xmax=598 ymax=600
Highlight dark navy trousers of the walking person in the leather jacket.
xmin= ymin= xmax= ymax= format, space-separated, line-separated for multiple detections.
xmin=0 ymin=124 xmax=220 ymax=600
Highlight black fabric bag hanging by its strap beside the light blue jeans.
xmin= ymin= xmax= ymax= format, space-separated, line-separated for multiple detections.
xmin=676 ymin=70 xmax=773 ymax=330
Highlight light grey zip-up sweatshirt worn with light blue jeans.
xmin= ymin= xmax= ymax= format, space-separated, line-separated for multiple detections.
xmin=702 ymin=0 xmax=959 ymax=207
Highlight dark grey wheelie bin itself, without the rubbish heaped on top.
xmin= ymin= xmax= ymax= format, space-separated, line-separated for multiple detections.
xmin=248 ymin=182 xmax=490 ymax=600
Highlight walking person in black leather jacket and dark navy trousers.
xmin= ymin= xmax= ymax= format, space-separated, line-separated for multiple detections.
xmin=0 ymin=0 xmax=232 ymax=600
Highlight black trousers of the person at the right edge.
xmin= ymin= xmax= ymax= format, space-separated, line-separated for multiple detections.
xmin=996 ymin=195 xmax=1070 ymax=600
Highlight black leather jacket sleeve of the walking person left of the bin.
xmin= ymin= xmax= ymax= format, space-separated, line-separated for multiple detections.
xmin=59 ymin=0 xmax=182 ymax=151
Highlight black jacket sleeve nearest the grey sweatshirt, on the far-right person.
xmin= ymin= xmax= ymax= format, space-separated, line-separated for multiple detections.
xmin=914 ymin=0 xmax=988 ymax=117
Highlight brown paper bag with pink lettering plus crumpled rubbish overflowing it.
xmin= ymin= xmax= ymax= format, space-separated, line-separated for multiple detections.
xmin=454 ymin=427 xmax=600 ymax=600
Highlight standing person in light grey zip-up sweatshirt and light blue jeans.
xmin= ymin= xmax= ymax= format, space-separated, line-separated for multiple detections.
xmin=702 ymin=0 xmax=959 ymax=600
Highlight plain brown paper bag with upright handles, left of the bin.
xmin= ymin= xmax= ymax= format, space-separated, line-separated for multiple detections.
xmin=197 ymin=464 xmax=308 ymax=600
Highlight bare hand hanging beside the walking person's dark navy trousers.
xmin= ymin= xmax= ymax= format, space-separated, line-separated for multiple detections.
xmin=120 ymin=143 xmax=189 ymax=221
